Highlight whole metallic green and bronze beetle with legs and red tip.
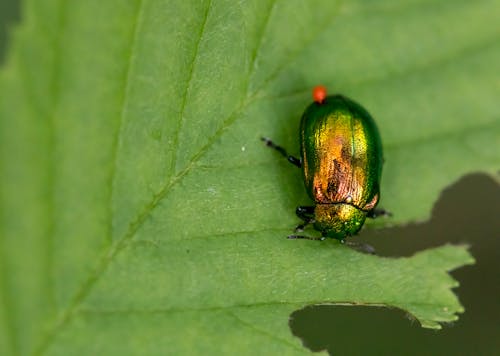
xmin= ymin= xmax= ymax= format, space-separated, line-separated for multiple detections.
xmin=262 ymin=86 xmax=389 ymax=241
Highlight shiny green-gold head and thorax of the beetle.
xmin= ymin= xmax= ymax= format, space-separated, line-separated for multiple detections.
xmin=314 ymin=203 xmax=366 ymax=240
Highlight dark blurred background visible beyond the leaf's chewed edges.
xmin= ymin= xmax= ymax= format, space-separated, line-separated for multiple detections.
xmin=0 ymin=0 xmax=500 ymax=355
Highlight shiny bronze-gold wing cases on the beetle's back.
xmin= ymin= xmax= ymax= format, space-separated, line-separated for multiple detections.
xmin=301 ymin=97 xmax=379 ymax=210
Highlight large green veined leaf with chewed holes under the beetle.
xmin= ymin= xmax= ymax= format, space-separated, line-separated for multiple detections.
xmin=0 ymin=0 xmax=500 ymax=355
